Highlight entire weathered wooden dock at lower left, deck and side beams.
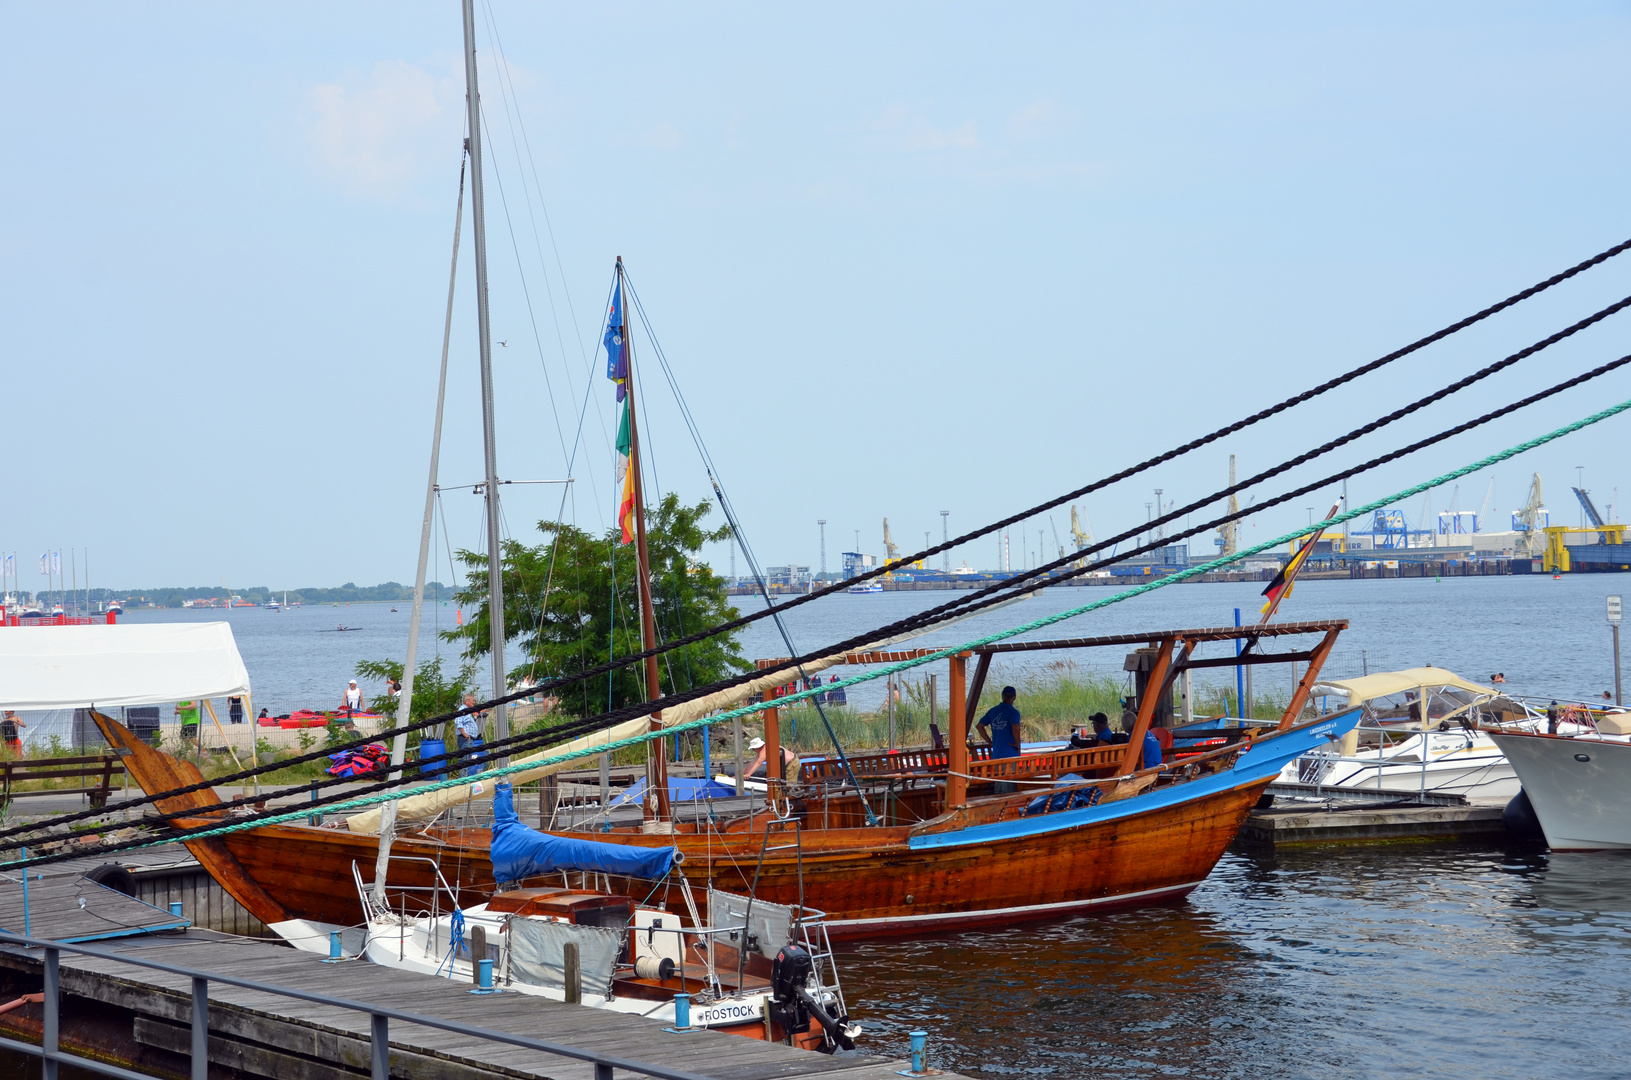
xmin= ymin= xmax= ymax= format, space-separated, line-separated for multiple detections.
xmin=0 ymin=873 xmax=957 ymax=1080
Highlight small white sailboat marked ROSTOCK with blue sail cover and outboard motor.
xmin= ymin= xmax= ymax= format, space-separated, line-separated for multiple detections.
xmin=271 ymin=781 xmax=861 ymax=1052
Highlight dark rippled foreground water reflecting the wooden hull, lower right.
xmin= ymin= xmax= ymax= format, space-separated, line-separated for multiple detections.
xmin=840 ymin=845 xmax=1631 ymax=1080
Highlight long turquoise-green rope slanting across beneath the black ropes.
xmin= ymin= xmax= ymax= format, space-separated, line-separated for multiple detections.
xmin=15 ymin=393 xmax=1631 ymax=866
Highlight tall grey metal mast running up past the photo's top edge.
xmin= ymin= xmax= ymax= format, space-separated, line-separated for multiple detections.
xmin=463 ymin=0 xmax=509 ymax=753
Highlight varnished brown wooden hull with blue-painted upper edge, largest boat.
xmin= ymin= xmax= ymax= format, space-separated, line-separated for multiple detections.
xmin=95 ymin=721 xmax=1356 ymax=936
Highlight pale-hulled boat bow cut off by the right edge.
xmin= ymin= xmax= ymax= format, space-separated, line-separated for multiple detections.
xmin=1489 ymin=711 xmax=1631 ymax=852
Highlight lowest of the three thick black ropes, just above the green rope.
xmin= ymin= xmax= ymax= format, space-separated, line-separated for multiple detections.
xmin=12 ymin=354 xmax=1631 ymax=865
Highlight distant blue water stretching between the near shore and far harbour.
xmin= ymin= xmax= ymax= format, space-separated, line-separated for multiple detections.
xmin=126 ymin=574 xmax=1631 ymax=713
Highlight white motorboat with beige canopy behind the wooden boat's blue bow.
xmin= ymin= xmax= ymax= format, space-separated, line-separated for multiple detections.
xmin=1280 ymin=667 xmax=1541 ymax=799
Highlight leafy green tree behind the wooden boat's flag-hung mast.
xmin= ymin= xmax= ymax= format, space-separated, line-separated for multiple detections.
xmin=442 ymin=493 xmax=747 ymax=716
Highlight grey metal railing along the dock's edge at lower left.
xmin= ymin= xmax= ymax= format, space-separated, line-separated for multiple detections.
xmin=0 ymin=932 xmax=706 ymax=1080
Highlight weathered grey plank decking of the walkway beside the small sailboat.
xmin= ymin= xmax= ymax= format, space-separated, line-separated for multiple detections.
xmin=0 ymin=932 xmax=932 ymax=1080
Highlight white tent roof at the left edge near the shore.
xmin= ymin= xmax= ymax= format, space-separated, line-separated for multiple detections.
xmin=0 ymin=623 xmax=250 ymax=711
